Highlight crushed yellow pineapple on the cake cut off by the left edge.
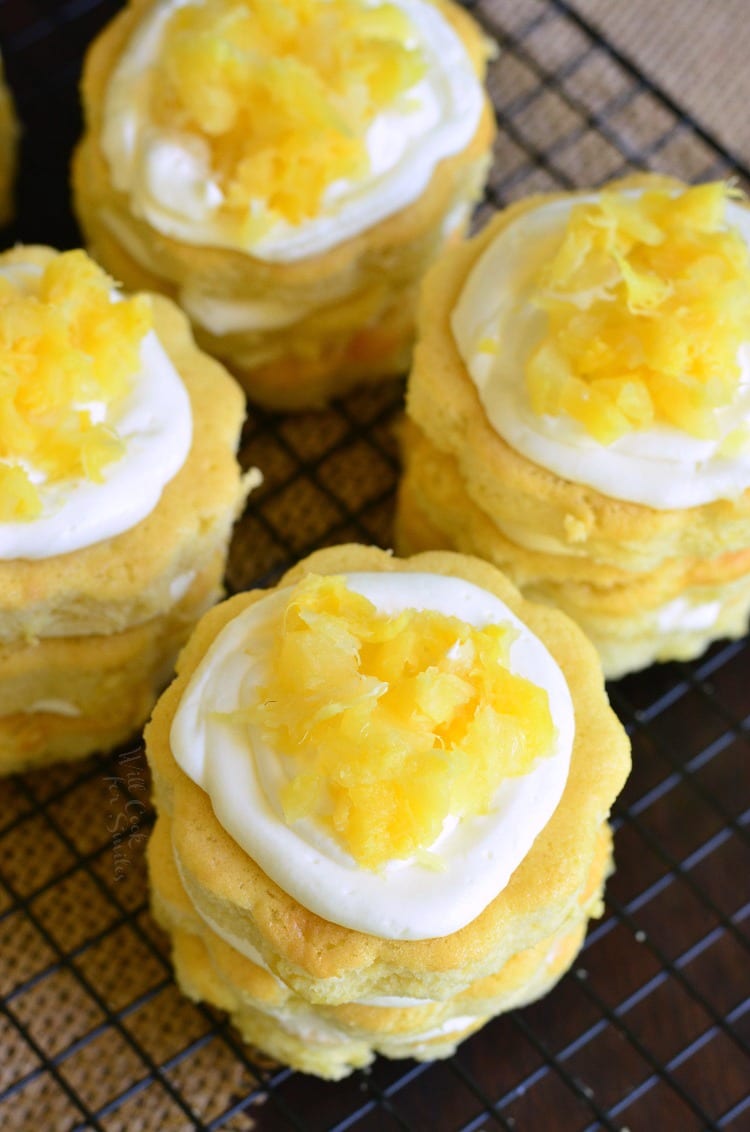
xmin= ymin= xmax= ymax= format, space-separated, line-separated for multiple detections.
xmin=0 ymin=251 xmax=152 ymax=522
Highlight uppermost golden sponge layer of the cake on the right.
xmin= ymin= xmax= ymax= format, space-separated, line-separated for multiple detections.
xmin=407 ymin=179 xmax=750 ymax=572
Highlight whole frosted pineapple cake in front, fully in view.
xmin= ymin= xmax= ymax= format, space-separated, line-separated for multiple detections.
xmin=146 ymin=546 xmax=629 ymax=1078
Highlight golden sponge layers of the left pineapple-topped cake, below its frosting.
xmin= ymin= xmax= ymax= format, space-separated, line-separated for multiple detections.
xmin=0 ymin=248 xmax=255 ymax=773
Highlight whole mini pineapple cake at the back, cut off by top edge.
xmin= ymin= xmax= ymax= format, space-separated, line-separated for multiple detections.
xmin=74 ymin=0 xmax=494 ymax=409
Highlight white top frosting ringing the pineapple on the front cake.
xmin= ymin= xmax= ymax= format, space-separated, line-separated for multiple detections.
xmin=171 ymin=573 xmax=575 ymax=940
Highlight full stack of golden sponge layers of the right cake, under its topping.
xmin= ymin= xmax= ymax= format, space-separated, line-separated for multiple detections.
xmin=396 ymin=178 xmax=750 ymax=677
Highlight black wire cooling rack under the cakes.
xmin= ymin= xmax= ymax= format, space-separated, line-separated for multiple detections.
xmin=0 ymin=0 xmax=750 ymax=1132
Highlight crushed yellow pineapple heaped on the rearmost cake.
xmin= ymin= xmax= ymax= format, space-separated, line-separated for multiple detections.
xmin=150 ymin=0 xmax=424 ymax=240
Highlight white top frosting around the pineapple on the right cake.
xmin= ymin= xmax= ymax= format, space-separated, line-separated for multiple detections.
xmin=451 ymin=196 xmax=750 ymax=511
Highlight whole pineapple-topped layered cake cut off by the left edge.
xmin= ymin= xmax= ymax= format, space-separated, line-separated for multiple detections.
xmin=0 ymin=247 xmax=256 ymax=773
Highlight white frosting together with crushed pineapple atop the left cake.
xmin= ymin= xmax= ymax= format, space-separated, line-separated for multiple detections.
xmin=0 ymin=251 xmax=192 ymax=559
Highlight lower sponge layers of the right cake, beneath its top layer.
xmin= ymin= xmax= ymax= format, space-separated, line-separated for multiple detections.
xmin=396 ymin=422 xmax=750 ymax=679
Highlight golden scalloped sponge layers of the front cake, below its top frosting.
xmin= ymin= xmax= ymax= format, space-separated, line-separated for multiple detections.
xmin=146 ymin=547 xmax=629 ymax=1078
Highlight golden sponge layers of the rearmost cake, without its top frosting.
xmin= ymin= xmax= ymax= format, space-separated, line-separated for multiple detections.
xmin=74 ymin=0 xmax=494 ymax=409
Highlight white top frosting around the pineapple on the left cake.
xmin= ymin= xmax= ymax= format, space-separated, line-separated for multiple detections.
xmin=0 ymin=264 xmax=192 ymax=559
